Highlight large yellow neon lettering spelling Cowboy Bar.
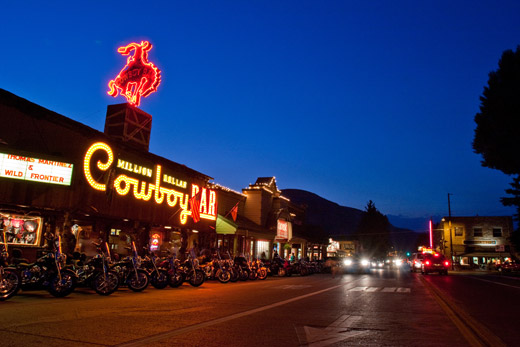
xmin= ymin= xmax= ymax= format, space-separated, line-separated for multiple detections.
xmin=83 ymin=142 xmax=217 ymax=224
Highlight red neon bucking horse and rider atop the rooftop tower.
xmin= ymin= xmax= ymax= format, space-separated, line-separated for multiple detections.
xmin=108 ymin=41 xmax=161 ymax=106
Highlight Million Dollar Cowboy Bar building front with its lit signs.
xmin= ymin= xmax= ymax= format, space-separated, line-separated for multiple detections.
xmin=0 ymin=90 xmax=218 ymax=259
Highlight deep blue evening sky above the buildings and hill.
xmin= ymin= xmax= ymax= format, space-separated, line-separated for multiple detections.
xmin=0 ymin=0 xmax=520 ymax=226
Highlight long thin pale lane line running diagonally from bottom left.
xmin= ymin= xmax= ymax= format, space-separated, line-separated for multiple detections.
xmin=116 ymin=282 xmax=352 ymax=347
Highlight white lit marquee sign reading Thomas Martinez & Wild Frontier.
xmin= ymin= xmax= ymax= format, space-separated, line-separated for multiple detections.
xmin=0 ymin=153 xmax=74 ymax=186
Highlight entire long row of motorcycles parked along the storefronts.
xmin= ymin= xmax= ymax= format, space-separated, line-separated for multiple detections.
xmin=0 ymin=238 xmax=321 ymax=301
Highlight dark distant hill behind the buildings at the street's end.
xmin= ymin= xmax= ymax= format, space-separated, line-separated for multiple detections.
xmin=282 ymin=189 xmax=426 ymax=251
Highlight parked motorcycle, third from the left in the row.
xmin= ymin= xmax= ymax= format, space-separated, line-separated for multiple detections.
xmin=74 ymin=242 xmax=119 ymax=295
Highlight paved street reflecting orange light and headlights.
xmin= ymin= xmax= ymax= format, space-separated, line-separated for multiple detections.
xmin=0 ymin=270 xmax=520 ymax=346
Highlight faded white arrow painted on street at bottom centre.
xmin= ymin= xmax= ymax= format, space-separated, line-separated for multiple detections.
xmin=297 ymin=315 xmax=370 ymax=347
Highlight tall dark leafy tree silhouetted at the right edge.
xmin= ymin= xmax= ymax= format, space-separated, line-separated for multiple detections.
xmin=473 ymin=46 xmax=520 ymax=249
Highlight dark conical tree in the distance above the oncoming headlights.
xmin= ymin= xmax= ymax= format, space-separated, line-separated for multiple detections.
xmin=355 ymin=200 xmax=391 ymax=257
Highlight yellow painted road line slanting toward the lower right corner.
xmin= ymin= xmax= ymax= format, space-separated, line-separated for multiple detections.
xmin=420 ymin=276 xmax=506 ymax=347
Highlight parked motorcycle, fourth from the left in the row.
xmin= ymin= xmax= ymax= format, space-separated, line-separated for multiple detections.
xmin=110 ymin=242 xmax=150 ymax=292
